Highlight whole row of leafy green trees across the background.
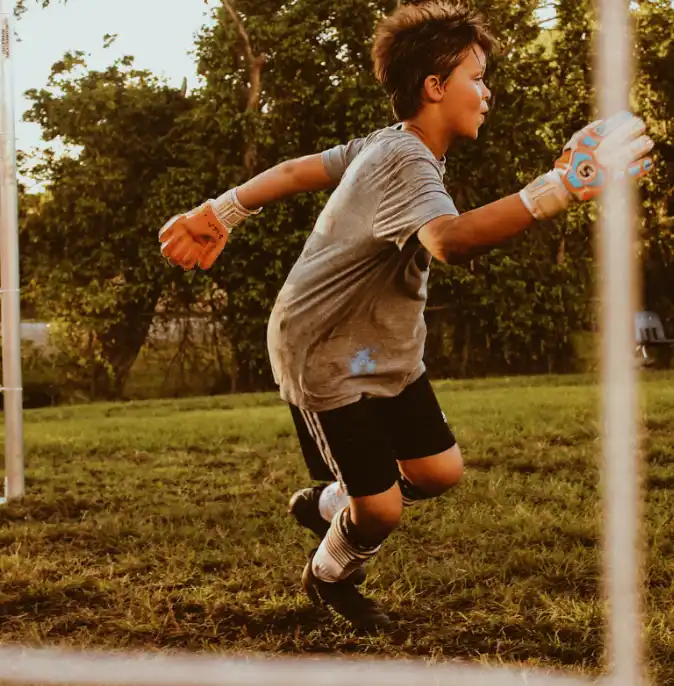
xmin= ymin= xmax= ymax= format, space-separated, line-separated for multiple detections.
xmin=17 ymin=0 xmax=674 ymax=395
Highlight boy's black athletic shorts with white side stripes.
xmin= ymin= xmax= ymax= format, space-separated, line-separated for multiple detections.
xmin=290 ymin=374 xmax=456 ymax=497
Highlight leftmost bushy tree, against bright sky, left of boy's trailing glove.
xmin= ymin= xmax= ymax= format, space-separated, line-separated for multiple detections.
xmin=21 ymin=52 xmax=194 ymax=397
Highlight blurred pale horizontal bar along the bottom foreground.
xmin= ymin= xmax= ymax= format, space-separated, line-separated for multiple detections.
xmin=0 ymin=647 xmax=601 ymax=686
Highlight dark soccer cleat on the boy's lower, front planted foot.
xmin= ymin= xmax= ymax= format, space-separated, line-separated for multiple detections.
xmin=302 ymin=550 xmax=392 ymax=630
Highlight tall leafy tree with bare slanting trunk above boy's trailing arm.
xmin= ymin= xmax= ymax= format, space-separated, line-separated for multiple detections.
xmin=184 ymin=0 xmax=393 ymax=390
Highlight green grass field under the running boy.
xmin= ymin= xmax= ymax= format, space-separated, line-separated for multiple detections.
xmin=0 ymin=374 xmax=674 ymax=684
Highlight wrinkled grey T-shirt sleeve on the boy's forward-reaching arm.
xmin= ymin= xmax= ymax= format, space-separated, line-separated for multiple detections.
xmin=373 ymin=156 xmax=459 ymax=250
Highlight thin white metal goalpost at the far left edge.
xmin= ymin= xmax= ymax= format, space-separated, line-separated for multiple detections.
xmin=0 ymin=0 xmax=25 ymax=500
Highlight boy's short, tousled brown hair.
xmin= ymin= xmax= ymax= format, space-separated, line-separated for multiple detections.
xmin=372 ymin=0 xmax=496 ymax=121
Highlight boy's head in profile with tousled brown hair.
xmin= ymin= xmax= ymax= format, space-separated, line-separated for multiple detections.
xmin=372 ymin=0 xmax=495 ymax=138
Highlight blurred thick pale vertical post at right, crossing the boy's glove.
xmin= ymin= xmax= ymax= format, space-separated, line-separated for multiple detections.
xmin=597 ymin=0 xmax=643 ymax=686
